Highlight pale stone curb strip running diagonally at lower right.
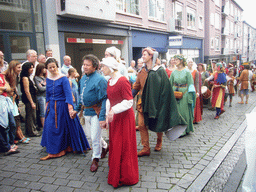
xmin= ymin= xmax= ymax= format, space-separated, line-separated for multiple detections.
xmin=186 ymin=111 xmax=249 ymax=192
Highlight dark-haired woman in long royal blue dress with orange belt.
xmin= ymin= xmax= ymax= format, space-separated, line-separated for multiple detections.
xmin=40 ymin=58 xmax=90 ymax=160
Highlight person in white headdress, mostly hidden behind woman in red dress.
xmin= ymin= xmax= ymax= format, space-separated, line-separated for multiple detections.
xmin=105 ymin=46 xmax=129 ymax=79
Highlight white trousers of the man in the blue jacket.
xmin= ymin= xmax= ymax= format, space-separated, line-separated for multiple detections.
xmin=83 ymin=115 xmax=108 ymax=160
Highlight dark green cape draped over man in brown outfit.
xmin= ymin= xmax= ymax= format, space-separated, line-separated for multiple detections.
xmin=142 ymin=67 xmax=187 ymax=132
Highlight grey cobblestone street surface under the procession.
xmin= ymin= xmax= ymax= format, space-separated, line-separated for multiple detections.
xmin=0 ymin=93 xmax=256 ymax=192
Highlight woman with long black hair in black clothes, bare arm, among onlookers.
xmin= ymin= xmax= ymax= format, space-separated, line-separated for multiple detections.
xmin=20 ymin=62 xmax=41 ymax=137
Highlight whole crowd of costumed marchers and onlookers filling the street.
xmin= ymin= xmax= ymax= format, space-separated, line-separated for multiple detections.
xmin=0 ymin=47 xmax=255 ymax=188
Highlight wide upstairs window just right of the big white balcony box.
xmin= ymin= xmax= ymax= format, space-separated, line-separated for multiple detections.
xmin=116 ymin=0 xmax=140 ymax=15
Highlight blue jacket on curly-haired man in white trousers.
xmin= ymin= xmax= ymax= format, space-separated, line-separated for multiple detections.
xmin=75 ymin=71 xmax=107 ymax=121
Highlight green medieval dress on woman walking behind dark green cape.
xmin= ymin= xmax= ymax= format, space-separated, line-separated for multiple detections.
xmin=170 ymin=68 xmax=196 ymax=135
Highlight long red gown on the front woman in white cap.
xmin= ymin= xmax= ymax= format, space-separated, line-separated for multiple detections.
xmin=107 ymin=76 xmax=139 ymax=187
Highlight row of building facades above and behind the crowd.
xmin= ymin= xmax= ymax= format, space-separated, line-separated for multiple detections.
xmin=0 ymin=0 xmax=256 ymax=68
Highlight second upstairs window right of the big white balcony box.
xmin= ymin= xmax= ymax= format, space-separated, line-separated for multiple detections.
xmin=149 ymin=0 xmax=165 ymax=21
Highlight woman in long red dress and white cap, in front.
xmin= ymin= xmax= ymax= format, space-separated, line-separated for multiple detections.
xmin=102 ymin=57 xmax=139 ymax=188
